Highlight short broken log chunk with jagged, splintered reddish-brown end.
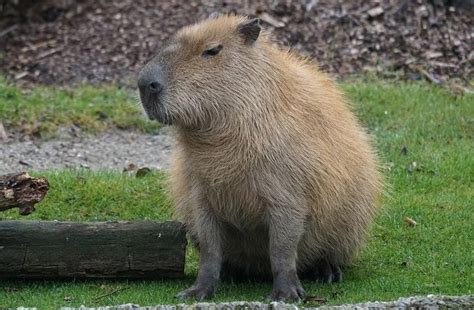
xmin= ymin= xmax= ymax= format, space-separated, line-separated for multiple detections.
xmin=0 ymin=172 xmax=49 ymax=215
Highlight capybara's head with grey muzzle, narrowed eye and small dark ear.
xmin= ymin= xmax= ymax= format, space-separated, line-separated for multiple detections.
xmin=138 ymin=16 xmax=266 ymax=129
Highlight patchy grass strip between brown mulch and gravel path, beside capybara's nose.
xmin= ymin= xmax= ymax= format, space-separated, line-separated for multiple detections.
xmin=0 ymin=76 xmax=160 ymax=138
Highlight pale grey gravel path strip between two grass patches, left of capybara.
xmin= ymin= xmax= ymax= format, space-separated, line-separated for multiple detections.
xmin=0 ymin=127 xmax=174 ymax=175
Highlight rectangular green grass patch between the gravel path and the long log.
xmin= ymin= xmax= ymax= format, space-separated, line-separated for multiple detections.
xmin=0 ymin=169 xmax=172 ymax=221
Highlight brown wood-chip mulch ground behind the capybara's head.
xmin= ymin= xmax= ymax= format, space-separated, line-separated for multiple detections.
xmin=0 ymin=0 xmax=474 ymax=85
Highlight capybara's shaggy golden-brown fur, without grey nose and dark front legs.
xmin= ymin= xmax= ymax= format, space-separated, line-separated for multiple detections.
xmin=140 ymin=16 xmax=381 ymax=300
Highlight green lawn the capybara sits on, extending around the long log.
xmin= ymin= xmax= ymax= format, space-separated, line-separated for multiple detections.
xmin=0 ymin=82 xmax=474 ymax=309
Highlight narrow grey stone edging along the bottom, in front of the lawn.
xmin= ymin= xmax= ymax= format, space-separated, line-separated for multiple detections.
xmin=12 ymin=295 xmax=474 ymax=310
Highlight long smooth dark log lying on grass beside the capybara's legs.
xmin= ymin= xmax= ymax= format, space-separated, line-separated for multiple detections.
xmin=0 ymin=221 xmax=186 ymax=279
